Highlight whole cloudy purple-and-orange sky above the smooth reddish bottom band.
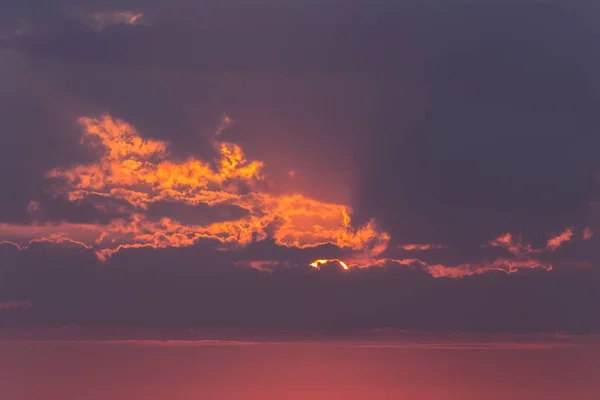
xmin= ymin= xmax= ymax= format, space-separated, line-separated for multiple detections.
xmin=0 ymin=0 xmax=600 ymax=333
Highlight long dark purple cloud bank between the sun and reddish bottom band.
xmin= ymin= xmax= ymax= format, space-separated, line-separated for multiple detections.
xmin=0 ymin=245 xmax=600 ymax=333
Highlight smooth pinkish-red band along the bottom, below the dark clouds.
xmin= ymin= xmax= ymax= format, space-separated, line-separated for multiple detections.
xmin=0 ymin=340 xmax=600 ymax=400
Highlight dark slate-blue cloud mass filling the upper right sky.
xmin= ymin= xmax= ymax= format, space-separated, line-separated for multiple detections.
xmin=350 ymin=4 xmax=600 ymax=247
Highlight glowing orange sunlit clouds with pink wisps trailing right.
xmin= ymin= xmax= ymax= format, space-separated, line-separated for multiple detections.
xmin=0 ymin=115 xmax=593 ymax=278
